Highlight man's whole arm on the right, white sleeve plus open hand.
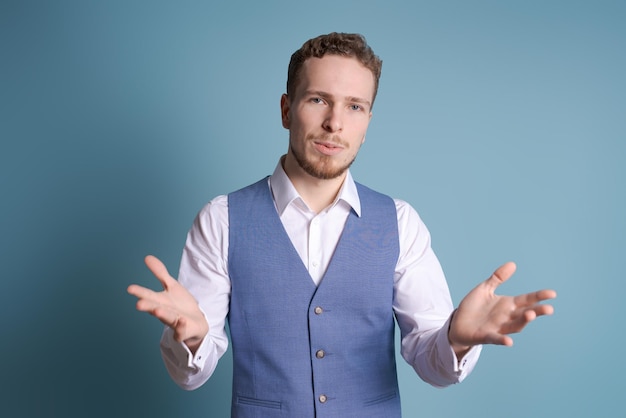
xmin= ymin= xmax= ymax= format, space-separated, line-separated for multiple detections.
xmin=394 ymin=201 xmax=556 ymax=386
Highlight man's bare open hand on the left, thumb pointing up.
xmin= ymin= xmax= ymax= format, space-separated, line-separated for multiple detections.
xmin=128 ymin=255 xmax=209 ymax=353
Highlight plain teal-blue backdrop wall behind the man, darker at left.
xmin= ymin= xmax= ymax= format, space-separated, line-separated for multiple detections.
xmin=0 ymin=0 xmax=626 ymax=417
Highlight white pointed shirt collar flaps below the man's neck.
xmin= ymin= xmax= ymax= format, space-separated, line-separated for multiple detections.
xmin=270 ymin=156 xmax=361 ymax=217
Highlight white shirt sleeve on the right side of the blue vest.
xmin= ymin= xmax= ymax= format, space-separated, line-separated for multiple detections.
xmin=393 ymin=200 xmax=482 ymax=387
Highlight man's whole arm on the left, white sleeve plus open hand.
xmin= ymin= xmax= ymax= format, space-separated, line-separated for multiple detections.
xmin=129 ymin=196 xmax=230 ymax=390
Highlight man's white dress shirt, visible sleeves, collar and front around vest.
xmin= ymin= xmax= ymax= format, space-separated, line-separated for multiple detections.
xmin=161 ymin=158 xmax=481 ymax=390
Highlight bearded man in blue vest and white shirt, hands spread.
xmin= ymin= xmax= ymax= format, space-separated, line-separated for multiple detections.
xmin=128 ymin=33 xmax=556 ymax=417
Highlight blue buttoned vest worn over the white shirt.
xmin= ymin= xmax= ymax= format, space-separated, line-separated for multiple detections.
xmin=228 ymin=178 xmax=401 ymax=418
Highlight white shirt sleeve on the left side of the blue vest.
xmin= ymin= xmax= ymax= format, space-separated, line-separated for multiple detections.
xmin=160 ymin=196 xmax=230 ymax=390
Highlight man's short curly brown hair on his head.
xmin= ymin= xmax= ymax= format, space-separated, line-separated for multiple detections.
xmin=287 ymin=32 xmax=383 ymax=104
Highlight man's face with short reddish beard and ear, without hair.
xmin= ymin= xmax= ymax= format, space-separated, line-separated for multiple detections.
xmin=281 ymin=55 xmax=374 ymax=179
